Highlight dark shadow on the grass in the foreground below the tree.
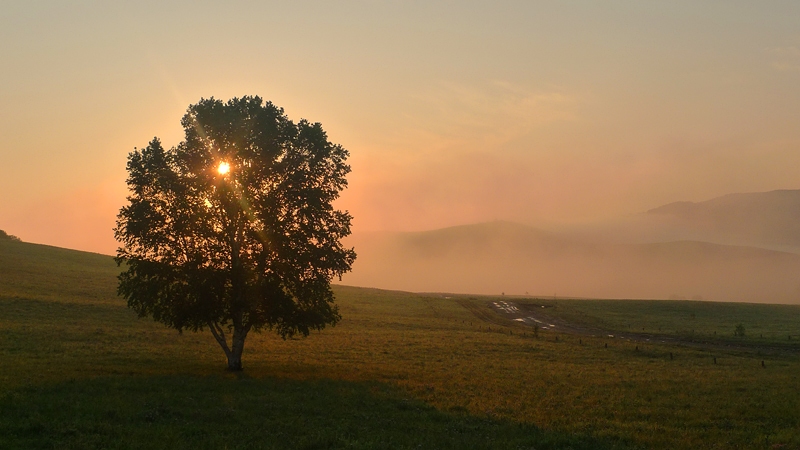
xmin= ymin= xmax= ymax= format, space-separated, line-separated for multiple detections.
xmin=0 ymin=376 xmax=625 ymax=449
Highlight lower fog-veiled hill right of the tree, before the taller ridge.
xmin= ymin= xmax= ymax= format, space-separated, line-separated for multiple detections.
xmin=342 ymin=218 xmax=800 ymax=303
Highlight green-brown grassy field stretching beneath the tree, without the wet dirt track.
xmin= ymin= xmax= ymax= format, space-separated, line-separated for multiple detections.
xmin=0 ymin=241 xmax=800 ymax=449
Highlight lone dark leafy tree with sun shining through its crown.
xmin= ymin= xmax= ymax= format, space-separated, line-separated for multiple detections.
xmin=114 ymin=97 xmax=356 ymax=370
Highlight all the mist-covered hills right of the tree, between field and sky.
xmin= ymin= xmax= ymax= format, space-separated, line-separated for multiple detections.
xmin=342 ymin=191 xmax=800 ymax=303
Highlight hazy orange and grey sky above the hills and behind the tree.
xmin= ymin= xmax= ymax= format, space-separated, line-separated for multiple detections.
xmin=0 ymin=0 xmax=800 ymax=254
